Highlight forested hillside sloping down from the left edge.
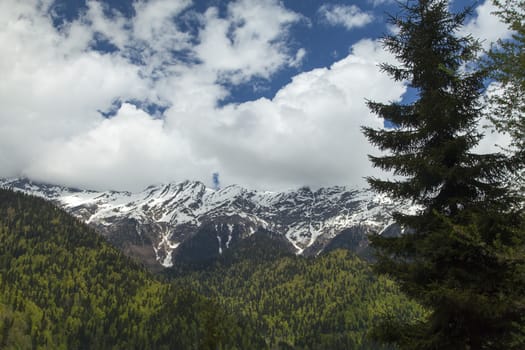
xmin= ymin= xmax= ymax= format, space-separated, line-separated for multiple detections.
xmin=0 ymin=190 xmax=241 ymax=349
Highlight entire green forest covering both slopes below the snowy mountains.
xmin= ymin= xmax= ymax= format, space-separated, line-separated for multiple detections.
xmin=0 ymin=190 xmax=423 ymax=349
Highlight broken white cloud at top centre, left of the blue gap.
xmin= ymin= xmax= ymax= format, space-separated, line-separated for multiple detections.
xmin=195 ymin=0 xmax=301 ymax=83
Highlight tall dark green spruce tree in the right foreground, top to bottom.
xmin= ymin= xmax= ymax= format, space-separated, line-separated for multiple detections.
xmin=363 ymin=0 xmax=525 ymax=350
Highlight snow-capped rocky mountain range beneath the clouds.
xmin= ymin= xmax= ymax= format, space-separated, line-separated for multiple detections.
xmin=0 ymin=179 xmax=415 ymax=267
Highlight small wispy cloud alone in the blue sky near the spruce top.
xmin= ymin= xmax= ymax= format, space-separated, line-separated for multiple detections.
xmin=319 ymin=4 xmax=374 ymax=30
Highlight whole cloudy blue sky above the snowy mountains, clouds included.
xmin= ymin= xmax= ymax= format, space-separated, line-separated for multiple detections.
xmin=0 ymin=0 xmax=509 ymax=191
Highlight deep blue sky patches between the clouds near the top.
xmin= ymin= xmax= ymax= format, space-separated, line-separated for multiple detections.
xmin=51 ymin=0 xmax=397 ymax=104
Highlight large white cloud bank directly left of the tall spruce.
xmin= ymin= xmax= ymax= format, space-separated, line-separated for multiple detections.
xmin=166 ymin=40 xmax=405 ymax=188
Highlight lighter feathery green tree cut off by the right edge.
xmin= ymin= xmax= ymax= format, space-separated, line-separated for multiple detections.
xmin=484 ymin=0 xmax=525 ymax=189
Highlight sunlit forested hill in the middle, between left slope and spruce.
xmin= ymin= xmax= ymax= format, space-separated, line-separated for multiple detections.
xmin=170 ymin=249 xmax=423 ymax=350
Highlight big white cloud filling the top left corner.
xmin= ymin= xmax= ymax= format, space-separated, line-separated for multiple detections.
xmin=0 ymin=1 xmax=149 ymax=186
